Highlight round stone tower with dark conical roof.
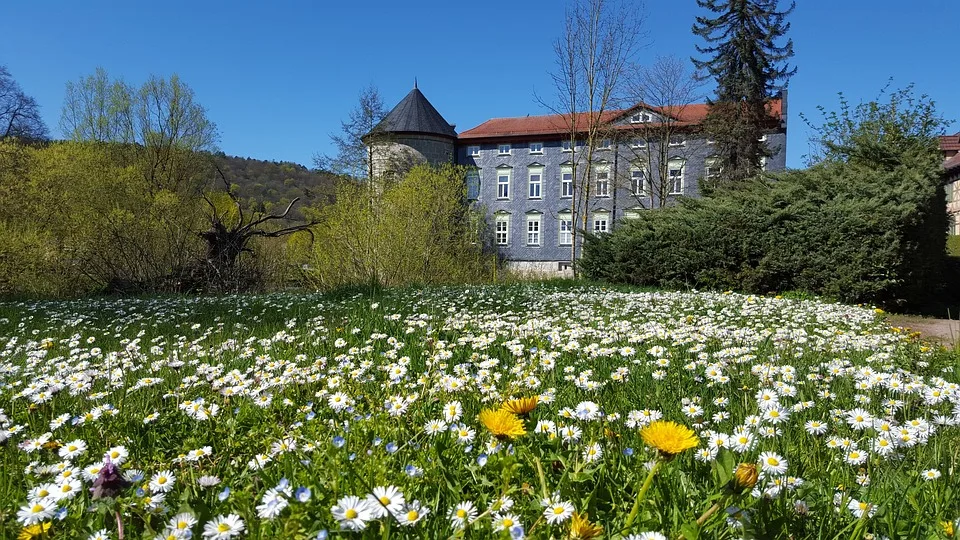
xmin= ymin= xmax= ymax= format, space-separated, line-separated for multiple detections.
xmin=363 ymin=83 xmax=457 ymax=178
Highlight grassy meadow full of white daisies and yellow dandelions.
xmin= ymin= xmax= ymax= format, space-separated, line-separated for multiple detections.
xmin=0 ymin=285 xmax=960 ymax=540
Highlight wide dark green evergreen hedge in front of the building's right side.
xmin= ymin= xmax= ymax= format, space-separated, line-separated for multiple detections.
xmin=580 ymin=152 xmax=947 ymax=308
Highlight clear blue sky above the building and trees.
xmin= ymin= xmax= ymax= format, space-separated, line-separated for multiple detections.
xmin=0 ymin=0 xmax=960 ymax=167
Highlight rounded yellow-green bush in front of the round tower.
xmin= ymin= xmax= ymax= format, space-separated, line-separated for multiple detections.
xmin=309 ymin=165 xmax=494 ymax=288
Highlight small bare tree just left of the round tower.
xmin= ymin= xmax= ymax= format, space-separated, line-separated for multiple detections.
xmin=314 ymin=85 xmax=389 ymax=179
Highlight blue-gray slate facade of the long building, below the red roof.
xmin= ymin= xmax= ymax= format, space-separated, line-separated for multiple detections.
xmin=456 ymin=129 xmax=786 ymax=269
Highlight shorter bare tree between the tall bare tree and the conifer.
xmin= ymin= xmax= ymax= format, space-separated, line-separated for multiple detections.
xmin=618 ymin=56 xmax=705 ymax=208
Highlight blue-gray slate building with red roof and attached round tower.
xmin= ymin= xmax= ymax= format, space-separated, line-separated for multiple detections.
xmin=367 ymin=86 xmax=787 ymax=275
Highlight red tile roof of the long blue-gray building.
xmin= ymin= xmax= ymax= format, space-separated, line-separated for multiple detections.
xmin=459 ymin=99 xmax=782 ymax=140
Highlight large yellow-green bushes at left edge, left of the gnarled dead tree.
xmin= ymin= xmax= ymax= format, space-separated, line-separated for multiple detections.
xmin=0 ymin=142 xmax=208 ymax=295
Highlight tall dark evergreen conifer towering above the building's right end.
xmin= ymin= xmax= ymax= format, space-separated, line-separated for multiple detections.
xmin=693 ymin=0 xmax=797 ymax=187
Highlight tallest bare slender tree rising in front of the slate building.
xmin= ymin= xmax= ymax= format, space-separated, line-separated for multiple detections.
xmin=537 ymin=0 xmax=644 ymax=276
